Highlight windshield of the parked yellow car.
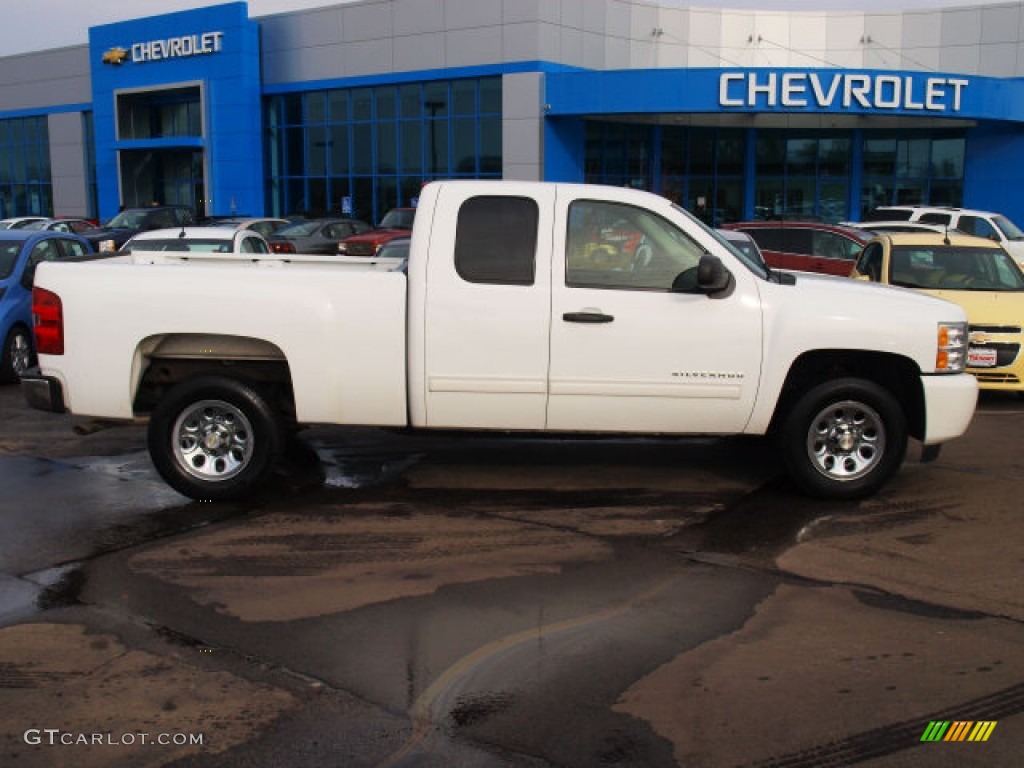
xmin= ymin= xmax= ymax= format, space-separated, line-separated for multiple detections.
xmin=889 ymin=246 xmax=1024 ymax=291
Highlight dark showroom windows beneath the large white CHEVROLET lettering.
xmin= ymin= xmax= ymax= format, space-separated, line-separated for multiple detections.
xmin=583 ymin=120 xmax=966 ymax=226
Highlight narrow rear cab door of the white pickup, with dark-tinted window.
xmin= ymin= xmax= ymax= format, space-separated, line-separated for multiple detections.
xmin=410 ymin=182 xmax=555 ymax=430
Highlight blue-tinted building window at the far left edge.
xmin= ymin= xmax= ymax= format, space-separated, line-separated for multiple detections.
xmin=0 ymin=115 xmax=53 ymax=218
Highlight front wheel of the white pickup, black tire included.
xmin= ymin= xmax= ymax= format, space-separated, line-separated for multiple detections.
xmin=781 ymin=379 xmax=907 ymax=499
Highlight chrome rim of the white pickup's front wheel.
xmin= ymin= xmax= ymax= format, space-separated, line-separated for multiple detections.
xmin=807 ymin=400 xmax=886 ymax=481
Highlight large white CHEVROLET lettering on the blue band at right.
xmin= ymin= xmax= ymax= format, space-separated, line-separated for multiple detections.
xmin=718 ymin=72 xmax=969 ymax=112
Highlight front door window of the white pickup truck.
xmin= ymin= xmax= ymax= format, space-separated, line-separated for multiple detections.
xmin=565 ymin=200 xmax=705 ymax=291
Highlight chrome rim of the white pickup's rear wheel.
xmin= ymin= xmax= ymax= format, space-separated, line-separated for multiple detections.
xmin=171 ymin=400 xmax=253 ymax=482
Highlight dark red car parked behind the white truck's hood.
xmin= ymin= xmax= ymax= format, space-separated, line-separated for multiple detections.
xmin=722 ymin=219 xmax=872 ymax=276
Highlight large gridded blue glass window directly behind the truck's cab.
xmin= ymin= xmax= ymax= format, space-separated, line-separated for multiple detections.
xmin=264 ymin=77 xmax=503 ymax=222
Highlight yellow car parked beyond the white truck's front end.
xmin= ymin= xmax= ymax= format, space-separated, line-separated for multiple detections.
xmin=850 ymin=232 xmax=1024 ymax=391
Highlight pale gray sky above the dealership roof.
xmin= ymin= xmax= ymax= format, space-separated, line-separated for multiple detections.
xmin=0 ymin=0 xmax=999 ymax=56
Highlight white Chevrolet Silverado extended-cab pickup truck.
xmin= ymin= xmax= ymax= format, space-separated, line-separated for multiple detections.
xmin=23 ymin=180 xmax=977 ymax=500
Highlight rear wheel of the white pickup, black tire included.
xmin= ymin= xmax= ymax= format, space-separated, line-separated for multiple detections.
xmin=148 ymin=376 xmax=285 ymax=502
